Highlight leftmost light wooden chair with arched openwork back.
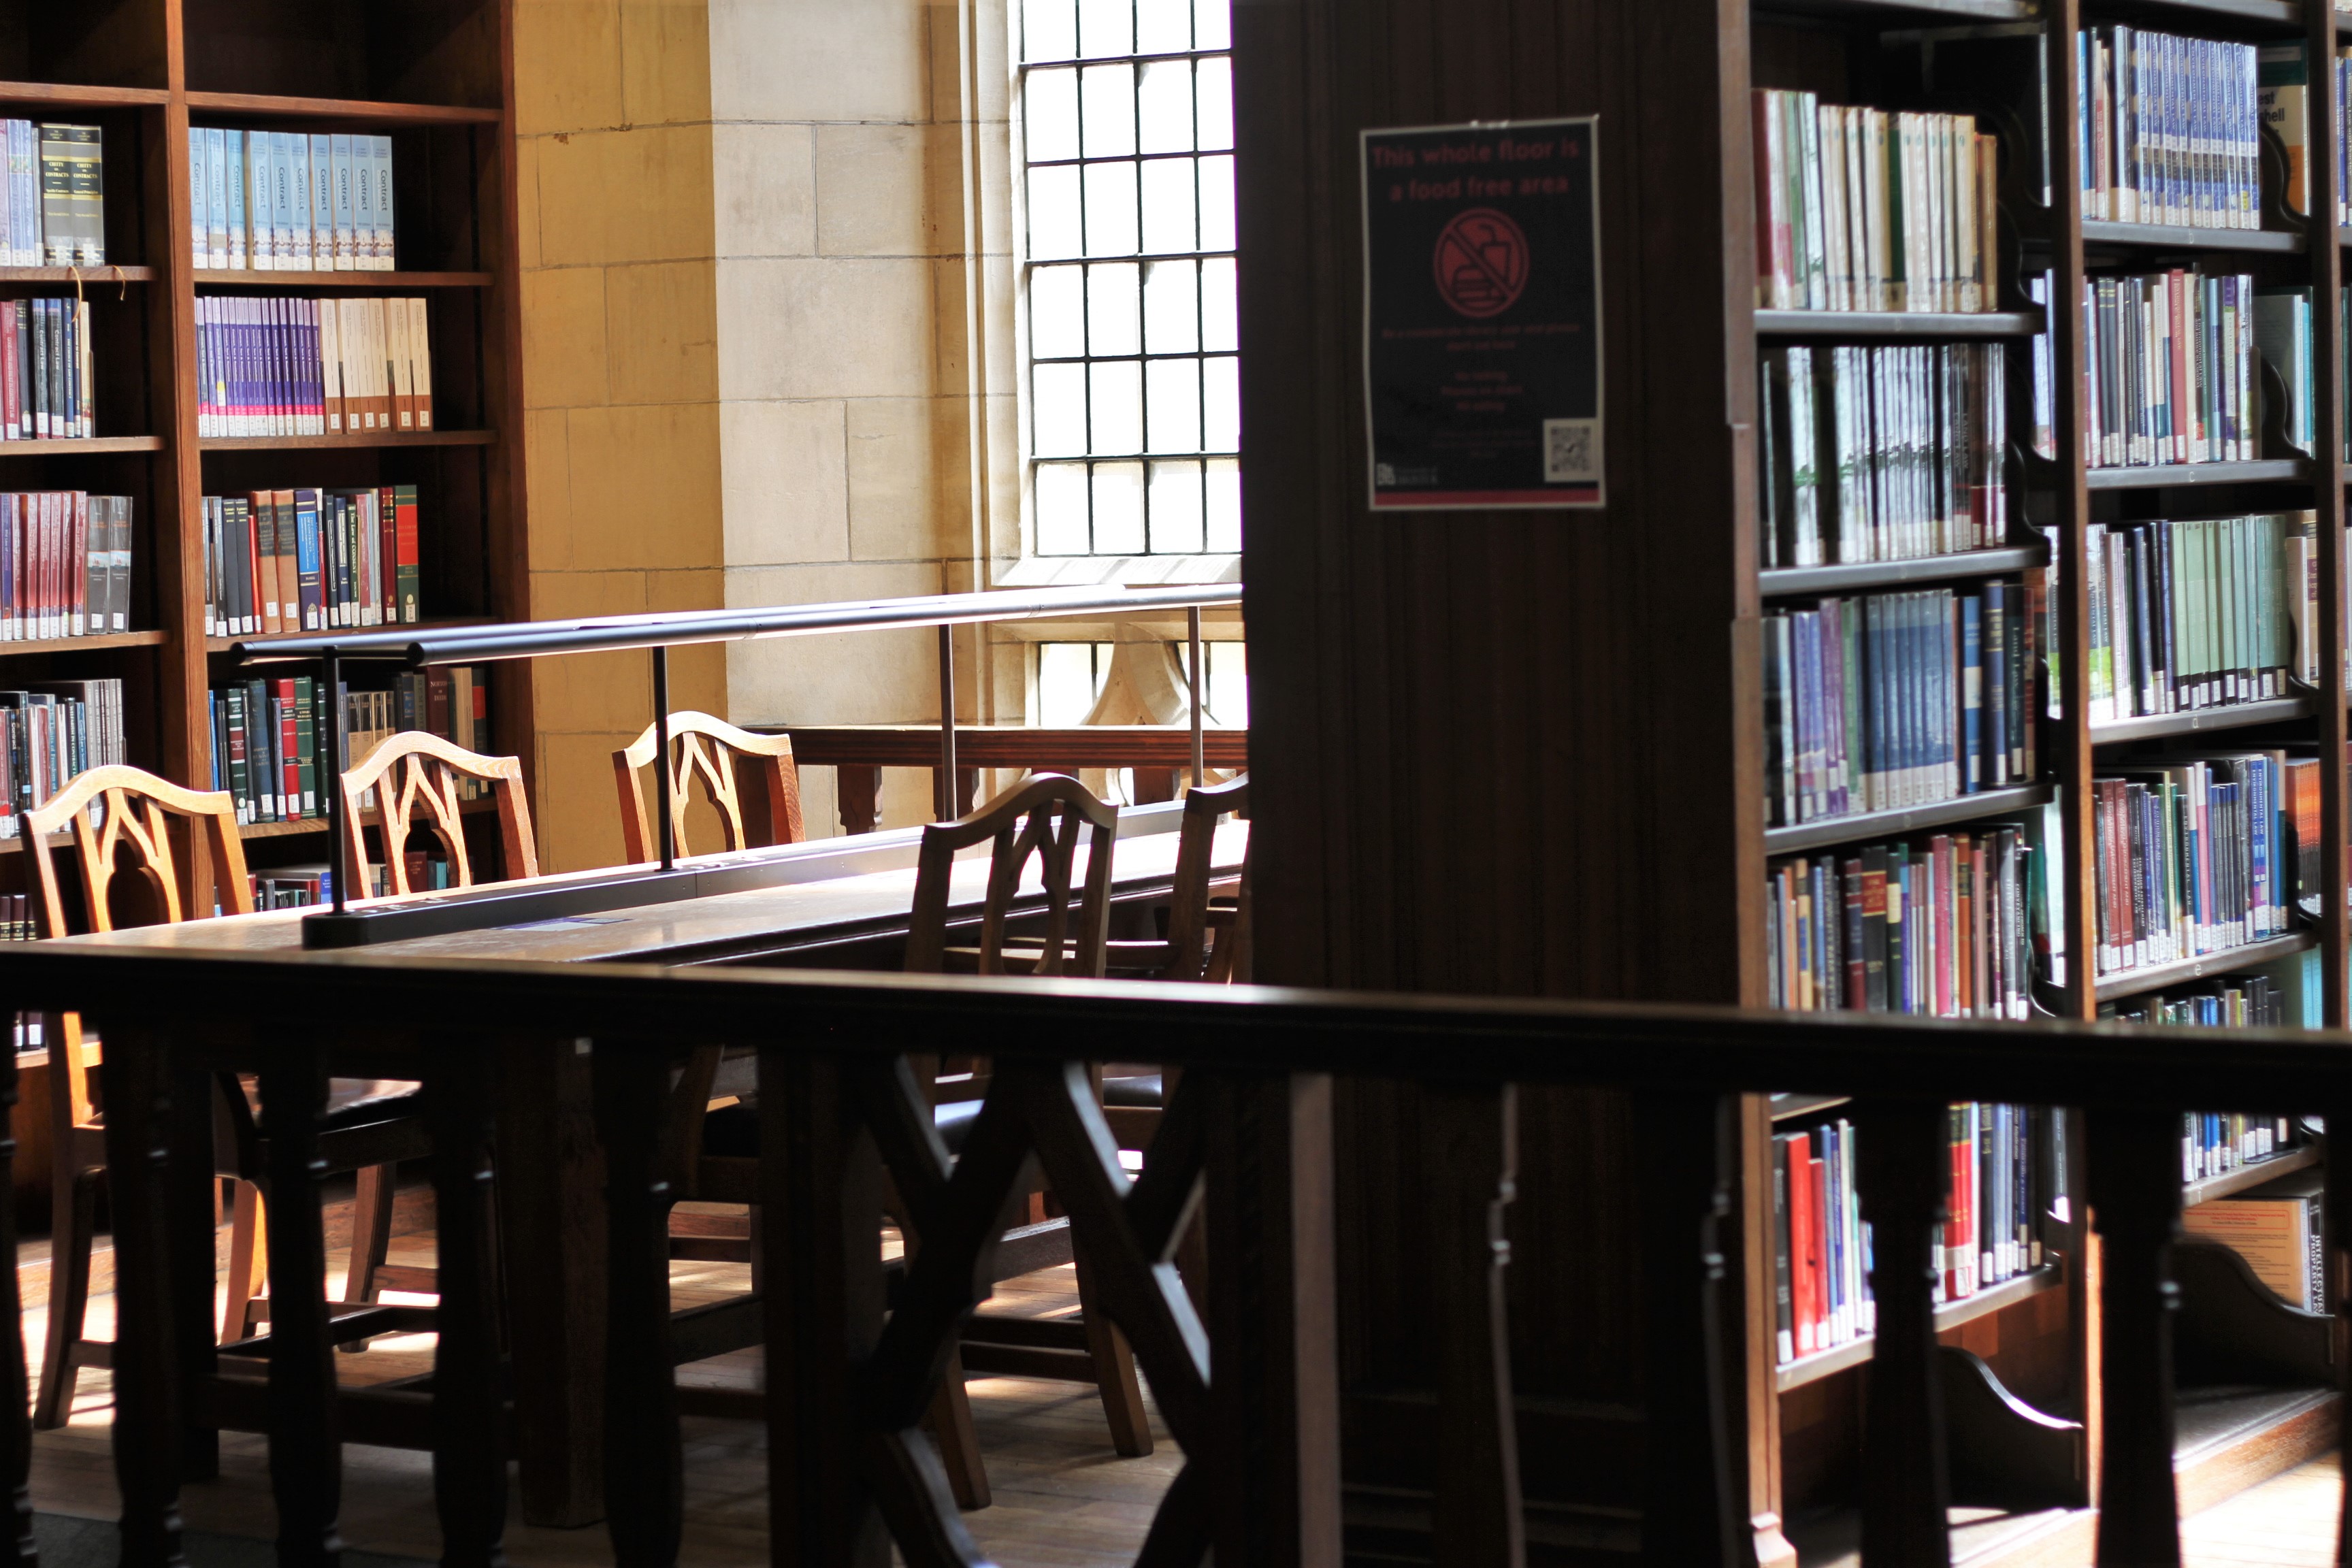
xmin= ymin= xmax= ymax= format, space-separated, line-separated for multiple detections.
xmin=24 ymin=766 xmax=430 ymax=1427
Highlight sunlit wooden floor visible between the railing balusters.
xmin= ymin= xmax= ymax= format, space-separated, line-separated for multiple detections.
xmin=19 ymin=1237 xmax=2342 ymax=1568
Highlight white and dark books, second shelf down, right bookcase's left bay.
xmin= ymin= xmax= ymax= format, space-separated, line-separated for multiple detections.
xmin=1757 ymin=343 xmax=2008 ymax=566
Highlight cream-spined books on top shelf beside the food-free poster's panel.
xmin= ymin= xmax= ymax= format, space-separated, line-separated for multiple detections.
xmin=1754 ymin=87 xmax=2002 ymax=310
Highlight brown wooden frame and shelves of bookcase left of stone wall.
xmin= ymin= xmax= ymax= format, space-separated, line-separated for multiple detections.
xmin=0 ymin=0 xmax=532 ymax=902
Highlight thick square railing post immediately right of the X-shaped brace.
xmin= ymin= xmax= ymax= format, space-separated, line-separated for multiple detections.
xmin=1190 ymin=1072 xmax=1341 ymax=1568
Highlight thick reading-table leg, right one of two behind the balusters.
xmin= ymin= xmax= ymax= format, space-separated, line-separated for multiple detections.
xmin=499 ymin=1039 xmax=604 ymax=1528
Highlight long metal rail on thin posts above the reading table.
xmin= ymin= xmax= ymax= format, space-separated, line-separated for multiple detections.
xmin=228 ymin=583 xmax=1242 ymax=933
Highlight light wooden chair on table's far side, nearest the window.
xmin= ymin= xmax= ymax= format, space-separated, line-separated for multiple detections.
xmin=612 ymin=710 xmax=802 ymax=1260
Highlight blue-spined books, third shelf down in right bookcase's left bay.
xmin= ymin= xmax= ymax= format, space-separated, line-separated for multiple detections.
xmin=1764 ymin=578 xmax=2037 ymax=828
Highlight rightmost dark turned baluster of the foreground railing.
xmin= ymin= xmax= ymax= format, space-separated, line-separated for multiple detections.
xmin=2089 ymin=1105 xmax=2180 ymax=1568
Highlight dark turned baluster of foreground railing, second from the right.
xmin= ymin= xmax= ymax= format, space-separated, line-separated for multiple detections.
xmin=1853 ymin=1102 xmax=1952 ymax=1568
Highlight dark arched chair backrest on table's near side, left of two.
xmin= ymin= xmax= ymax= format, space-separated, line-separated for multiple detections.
xmin=906 ymin=773 xmax=1120 ymax=976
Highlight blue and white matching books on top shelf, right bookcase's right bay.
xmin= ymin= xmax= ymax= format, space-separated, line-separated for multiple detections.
xmin=2074 ymin=26 xmax=2263 ymax=228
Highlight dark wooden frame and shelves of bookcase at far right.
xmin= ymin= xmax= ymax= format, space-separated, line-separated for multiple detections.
xmin=1722 ymin=0 xmax=2352 ymax=1566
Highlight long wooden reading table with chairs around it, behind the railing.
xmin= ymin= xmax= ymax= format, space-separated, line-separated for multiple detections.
xmin=46 ymin=811 xmax=1249 ymax=1526
